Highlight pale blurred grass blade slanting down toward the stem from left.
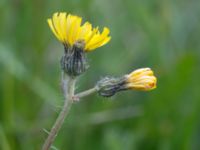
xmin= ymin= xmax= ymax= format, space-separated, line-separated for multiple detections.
xmin=0 ymin=44 xmax=59 ymax=106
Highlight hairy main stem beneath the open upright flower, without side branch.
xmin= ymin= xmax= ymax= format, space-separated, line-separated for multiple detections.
xmin=42 ymin=73 xmax=75 ymax=150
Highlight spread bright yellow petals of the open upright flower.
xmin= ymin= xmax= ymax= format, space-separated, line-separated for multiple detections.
xmin=47 ymin=12 xmax=111 ymax=52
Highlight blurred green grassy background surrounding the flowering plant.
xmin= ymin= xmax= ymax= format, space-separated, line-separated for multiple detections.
xmin=0 ymin=0 xmax=200 ymax=150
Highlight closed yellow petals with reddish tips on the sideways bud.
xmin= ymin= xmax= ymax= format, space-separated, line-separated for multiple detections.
xmin=126 ymin=68 xmax=157 ymax=91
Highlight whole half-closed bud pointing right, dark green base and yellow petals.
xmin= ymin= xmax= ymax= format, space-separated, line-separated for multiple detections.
xmin=97 ymin=68 xmax=157 ymax=97
